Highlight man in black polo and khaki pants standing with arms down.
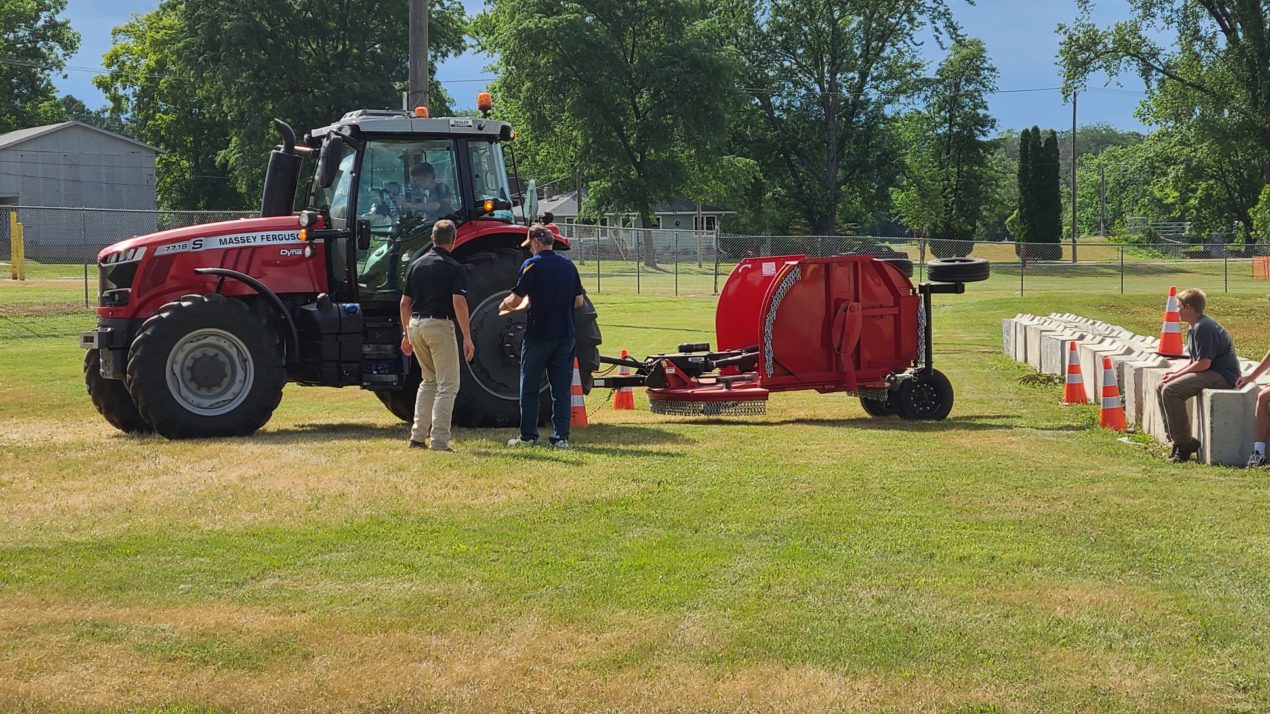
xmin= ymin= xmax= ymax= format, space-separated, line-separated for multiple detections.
xmin=401 ymin=221 xmax=476 ymax=451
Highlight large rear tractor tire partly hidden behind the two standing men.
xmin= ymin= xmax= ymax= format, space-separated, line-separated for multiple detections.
xmin=376 ymin=248 xmax=601 ymax=428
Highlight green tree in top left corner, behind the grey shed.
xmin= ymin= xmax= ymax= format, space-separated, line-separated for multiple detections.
xmin=0 ymin=0 xmax=80 ymax=133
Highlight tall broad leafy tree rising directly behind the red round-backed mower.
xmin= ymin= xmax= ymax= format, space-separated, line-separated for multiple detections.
xmin=729 ymin=0 xmax=958 ymax=235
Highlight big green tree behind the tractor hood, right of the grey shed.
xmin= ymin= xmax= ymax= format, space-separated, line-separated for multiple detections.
xmin=94 ymin=0 xmax=466 ymax=208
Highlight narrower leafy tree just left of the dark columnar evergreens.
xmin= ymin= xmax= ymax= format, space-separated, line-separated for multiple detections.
xmin=893 ymin=39 xmax=997 ymax=258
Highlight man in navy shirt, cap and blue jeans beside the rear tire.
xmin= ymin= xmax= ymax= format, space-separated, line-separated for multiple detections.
xmin=500 ymin=224 xmax=583 ymax=448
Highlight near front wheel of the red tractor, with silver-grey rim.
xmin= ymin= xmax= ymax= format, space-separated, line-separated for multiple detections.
xmin=128 ymin=295 xmax=287 ymax=438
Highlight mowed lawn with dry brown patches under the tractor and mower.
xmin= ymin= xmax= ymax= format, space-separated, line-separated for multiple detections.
xmin=0 ymin=286 xmax=1270 ymax=711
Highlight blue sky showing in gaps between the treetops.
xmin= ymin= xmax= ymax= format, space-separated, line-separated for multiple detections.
xmin=55 ymin=0 xmax=1144 ymax=130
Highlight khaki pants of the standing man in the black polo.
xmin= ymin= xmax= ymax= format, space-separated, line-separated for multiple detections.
xmin=408 ymin=318 xmax=458 ymax=448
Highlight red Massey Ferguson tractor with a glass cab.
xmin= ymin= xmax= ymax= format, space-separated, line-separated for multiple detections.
xmin=80 ymin=109 xmax=601 ymax=438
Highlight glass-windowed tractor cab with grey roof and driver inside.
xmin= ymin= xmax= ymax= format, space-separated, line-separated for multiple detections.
xmin=275 ymin=109 xmax=514 ymax=302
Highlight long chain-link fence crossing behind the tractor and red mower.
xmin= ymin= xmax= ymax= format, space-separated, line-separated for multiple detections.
xmin=7 ymin=206 xmax=1270 ymax=339
